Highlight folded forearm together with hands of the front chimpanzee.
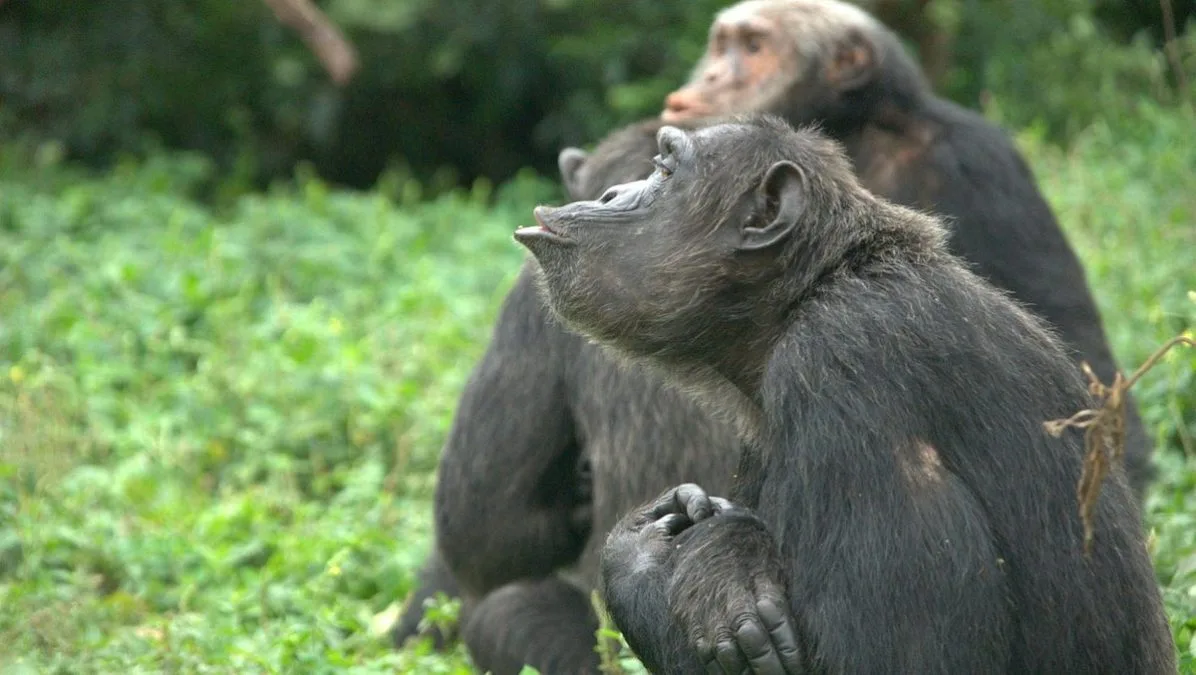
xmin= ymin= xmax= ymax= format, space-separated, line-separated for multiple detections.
xmin=602 ymin=485 xmax=803 ymax=675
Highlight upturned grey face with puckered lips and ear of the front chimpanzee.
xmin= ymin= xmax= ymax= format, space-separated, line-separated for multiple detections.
xmin=514 ymin=117 xmax=826 ymax=363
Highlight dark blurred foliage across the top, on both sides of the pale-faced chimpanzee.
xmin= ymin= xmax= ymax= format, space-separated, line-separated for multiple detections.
xmin=0 ymin=0 xmax=1196 ymax=190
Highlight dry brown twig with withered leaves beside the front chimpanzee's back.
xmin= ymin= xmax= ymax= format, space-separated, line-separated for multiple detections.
xmin=1043 ymin=335 xmax=1196 ymax=553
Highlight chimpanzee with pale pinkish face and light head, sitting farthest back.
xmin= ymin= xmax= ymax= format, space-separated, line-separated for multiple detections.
xmin=655 ymin=0 xmax=1154 ymax=490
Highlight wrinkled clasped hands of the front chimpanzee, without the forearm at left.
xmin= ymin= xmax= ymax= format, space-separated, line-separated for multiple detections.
xmin=605 ymin=484 xmax=804 ymax=675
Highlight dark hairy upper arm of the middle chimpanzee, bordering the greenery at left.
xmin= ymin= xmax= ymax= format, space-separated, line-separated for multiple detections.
xmin=435 ymin=267 xmax=590 ymax=595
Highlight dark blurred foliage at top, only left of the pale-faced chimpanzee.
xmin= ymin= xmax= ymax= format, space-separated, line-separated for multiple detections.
xmin=0 ymin=0 xmax=719 ymax=192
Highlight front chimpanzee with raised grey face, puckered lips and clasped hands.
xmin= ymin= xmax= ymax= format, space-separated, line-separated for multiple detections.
xmin=515 ymin=116 xmax=1176 ymax=675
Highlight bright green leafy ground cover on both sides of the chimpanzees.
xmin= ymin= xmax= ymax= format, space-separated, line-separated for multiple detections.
xmin=0 ymin=101 xmax=1196 ymax=674
